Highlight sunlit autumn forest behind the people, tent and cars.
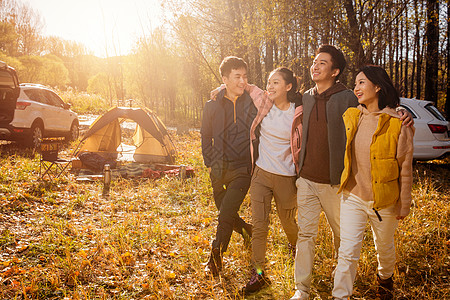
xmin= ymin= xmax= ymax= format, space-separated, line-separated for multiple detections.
xmin=0 ymin=0 xmax=450 ymax=126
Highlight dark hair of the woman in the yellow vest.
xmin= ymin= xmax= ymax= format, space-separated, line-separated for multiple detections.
xmin=360 ymin=65 xmax=400 ymax=109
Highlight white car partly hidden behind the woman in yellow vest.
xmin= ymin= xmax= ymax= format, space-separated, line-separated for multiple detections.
xmin=400 ymin=98 xmax=450 ymax=160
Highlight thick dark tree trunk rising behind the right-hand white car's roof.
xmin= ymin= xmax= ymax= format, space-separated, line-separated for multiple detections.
xmin=425 ymin=0 xmax=439 ymax=104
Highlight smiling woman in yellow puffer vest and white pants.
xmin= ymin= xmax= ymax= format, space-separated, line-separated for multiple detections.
xmin=333 ymin=66 xmax=414 ymax=299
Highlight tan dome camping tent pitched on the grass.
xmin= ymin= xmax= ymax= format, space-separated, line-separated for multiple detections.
xmin=79 ymin=107 xmax=176 ymax=164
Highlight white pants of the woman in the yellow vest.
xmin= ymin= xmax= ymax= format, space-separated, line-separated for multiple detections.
xmin=333 ymin=194 xmax=398 ymax=299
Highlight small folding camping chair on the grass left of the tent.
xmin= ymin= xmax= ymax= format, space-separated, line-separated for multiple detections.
xmin=39 ymin=139 xmax=71 ymax=179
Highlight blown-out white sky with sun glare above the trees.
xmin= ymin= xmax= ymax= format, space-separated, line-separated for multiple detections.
xmin=28 ymin=0 xmax=162 ymax=57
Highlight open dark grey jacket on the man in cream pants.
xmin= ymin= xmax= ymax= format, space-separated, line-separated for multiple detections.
xmin=298 ymin=89 xmax=358 ymax=185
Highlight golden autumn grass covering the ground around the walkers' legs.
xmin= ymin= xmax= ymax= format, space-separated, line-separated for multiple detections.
xmin=0 ymin=132 xmax=450 ymax=299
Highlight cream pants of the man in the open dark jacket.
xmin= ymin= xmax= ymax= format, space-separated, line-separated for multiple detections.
xmin=294 ymin=177 xmax=340 ymax=298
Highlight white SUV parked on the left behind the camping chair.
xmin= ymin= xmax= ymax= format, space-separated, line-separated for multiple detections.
xmin=0 ymin=83 xmax=79 ymax=147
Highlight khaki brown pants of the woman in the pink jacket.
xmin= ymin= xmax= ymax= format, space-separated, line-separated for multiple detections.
xmin=250 ymin=166 xmax=298 ymax=270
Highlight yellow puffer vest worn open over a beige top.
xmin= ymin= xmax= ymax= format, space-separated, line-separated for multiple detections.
xmin=338 ymin=107 xmax=402 ymax=210
